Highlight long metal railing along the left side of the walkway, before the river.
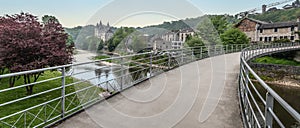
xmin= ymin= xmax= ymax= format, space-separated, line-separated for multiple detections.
xmin=0 ymin=44 xmax=253 ymax=128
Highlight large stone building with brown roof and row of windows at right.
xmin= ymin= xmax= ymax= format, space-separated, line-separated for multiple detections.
xmin=235 ymin=18 xmax=300 ymax=42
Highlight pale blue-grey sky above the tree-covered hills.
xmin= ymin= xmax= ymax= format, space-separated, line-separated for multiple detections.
xmin=0 ymin=0 xmax=291 ymax=27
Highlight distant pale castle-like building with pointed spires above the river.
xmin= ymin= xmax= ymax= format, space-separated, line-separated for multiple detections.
xmin=95 ymin=21 xmax=114 ymax=41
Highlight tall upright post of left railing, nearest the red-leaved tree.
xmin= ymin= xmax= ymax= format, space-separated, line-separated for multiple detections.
xmin=61 ymin=67 xmax=66 ymax=118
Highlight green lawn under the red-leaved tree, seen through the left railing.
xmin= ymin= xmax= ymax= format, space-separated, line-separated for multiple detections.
xmin=0 ymin=71 xmax=103 ymax=128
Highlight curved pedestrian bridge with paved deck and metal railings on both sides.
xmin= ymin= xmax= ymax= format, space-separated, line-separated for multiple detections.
xmin=0 ymin=43 xmax=300 ymax=128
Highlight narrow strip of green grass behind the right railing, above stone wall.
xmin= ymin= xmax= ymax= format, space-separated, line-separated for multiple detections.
xmin=253 ymin=56 xmax=300 ymax=66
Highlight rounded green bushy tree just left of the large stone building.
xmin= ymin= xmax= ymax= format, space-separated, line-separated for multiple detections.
xmin=221 ymin=28 xmax=249 ymax=45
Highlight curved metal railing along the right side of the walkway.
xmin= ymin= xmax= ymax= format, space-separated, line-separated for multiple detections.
xmin=239 ymin=43 xmax=300 ymax=128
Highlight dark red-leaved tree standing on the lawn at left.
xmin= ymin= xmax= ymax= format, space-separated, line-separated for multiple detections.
xmin=0 ymin=13 xmax=73 ymax=94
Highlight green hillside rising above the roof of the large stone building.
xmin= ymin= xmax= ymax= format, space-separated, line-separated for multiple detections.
xmin=249 ymin=8 xmax=300 ymax=22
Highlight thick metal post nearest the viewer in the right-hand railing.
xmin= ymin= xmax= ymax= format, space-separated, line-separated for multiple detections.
xmin=265 ymin=92 xmax=274 ymax=128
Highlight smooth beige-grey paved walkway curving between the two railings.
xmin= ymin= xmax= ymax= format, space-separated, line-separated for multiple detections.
xmin=57 ymin=53 xmax=242 ymax=128
